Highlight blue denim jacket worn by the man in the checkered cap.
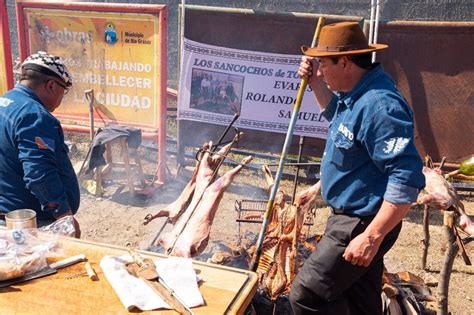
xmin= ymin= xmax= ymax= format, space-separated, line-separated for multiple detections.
xmin=0 ymin=84 xmax=80 ymax=219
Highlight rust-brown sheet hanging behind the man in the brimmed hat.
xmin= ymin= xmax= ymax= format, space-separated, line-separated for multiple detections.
xmin=379 ymin=22 xmax=474 ymax=162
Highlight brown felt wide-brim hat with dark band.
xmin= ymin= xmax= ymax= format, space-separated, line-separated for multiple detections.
xmin=301 ymin=22 xmax=388 ymax=57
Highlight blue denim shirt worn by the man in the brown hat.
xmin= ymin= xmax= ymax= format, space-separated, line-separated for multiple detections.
xmin=321 ymin=64 xmax=425 ymax=216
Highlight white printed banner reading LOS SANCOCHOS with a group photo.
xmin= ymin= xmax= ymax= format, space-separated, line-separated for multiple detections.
xmin=178 ymin=39 xmax=328 ymax=139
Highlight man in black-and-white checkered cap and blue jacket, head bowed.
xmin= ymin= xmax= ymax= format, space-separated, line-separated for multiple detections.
xmin=0 ymin=52 xmax=80 ymax=237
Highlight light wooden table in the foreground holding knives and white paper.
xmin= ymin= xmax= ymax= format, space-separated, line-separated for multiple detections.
xmin=0 ymin=238 xmax=257 ymax=315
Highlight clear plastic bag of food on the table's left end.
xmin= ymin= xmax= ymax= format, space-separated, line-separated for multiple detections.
xmin=0 ymin=229 xmax=62 ymax=281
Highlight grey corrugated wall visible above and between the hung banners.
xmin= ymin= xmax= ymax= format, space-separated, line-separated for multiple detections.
xmin=7 ymin=0 xmax=474 ymax=87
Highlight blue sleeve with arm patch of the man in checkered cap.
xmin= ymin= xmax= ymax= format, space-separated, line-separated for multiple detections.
xmin=15 ymin=112 xmax=71 ymax=217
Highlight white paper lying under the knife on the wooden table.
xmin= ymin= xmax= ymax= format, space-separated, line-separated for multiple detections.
xmin=100 ymin=255 xmax=204 ymax=311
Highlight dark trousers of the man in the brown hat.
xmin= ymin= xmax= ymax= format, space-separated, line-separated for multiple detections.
xmin=290 ymin=214 xmax=402 ymax=315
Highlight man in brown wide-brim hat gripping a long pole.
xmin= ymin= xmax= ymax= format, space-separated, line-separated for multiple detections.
xmin=290 ymin=22 xmax=425 ymax=314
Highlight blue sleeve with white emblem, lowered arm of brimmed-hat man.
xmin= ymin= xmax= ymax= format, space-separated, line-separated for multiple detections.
xmin=362 ymin=94 xmax=425 ymax=204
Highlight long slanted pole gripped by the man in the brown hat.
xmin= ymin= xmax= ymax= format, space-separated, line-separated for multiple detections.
xmin=250 ymin=17 xmax=324 ymax=271
